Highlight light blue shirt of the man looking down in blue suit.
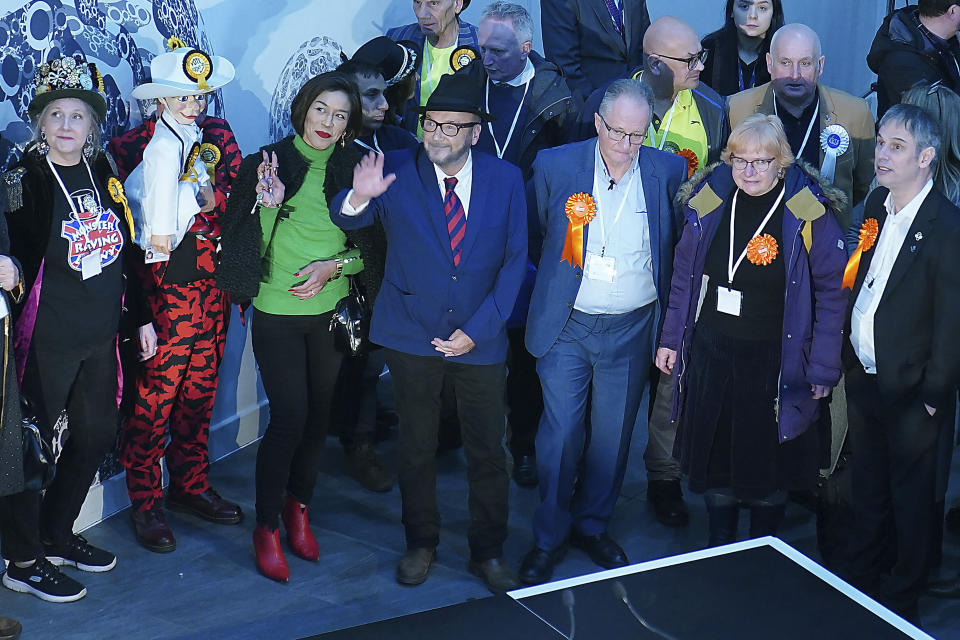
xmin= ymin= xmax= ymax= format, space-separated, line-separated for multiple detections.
xmin=573 ymin=145 xmax=657 ymax=314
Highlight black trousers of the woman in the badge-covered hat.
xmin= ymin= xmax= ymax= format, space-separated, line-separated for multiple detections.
xmin=0 ymin=338 xmax=118 ymax=562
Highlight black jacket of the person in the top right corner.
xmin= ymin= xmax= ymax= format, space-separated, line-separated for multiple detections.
xmin=867 ymin=6 xmax=960 ymax=120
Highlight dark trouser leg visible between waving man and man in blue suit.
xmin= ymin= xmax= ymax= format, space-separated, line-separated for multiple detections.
xmin=507 ymin=327 xmax=543 ymax=458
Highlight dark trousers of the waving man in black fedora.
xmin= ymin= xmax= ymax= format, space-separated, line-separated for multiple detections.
xmin=387 ymin=349 xmax=509 ymax=562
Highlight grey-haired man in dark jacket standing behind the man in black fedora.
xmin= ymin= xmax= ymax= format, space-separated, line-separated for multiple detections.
xmin=458 ymin=0 xmax=578 ymax=487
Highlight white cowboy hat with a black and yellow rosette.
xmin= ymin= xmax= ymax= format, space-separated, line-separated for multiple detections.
xmin=131 ymin=47 xmax=236 ymax=100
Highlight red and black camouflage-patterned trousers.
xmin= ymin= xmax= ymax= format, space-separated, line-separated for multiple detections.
xmin=121 ymin=279 xmax=229 ymax=511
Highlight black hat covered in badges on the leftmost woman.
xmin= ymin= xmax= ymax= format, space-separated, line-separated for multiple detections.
xmin=27 ymin=54 xmax=107 ymax=121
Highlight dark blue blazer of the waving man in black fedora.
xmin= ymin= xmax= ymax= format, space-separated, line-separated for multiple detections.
xmin=330 ymin=147 xmax=527 ymax=364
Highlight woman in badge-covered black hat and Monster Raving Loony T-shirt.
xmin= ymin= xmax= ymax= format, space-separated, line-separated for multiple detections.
xmin=0 ymin=56 xmax=157 ymax=602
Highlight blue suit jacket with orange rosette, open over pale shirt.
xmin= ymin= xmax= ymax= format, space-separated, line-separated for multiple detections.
xmin=526 ymin=138 xmax=687 ymax=358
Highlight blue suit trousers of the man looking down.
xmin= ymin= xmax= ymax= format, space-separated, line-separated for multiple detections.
xmin=533 ymin=304 xmax=656 ymax=551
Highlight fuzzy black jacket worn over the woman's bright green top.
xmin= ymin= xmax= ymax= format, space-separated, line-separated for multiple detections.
xmin=216 ymin=136 xmax=362 ymax=304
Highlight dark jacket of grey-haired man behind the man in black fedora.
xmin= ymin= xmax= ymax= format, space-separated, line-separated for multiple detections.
xmin=457 ymin=51 xmax=580 ymax=180
